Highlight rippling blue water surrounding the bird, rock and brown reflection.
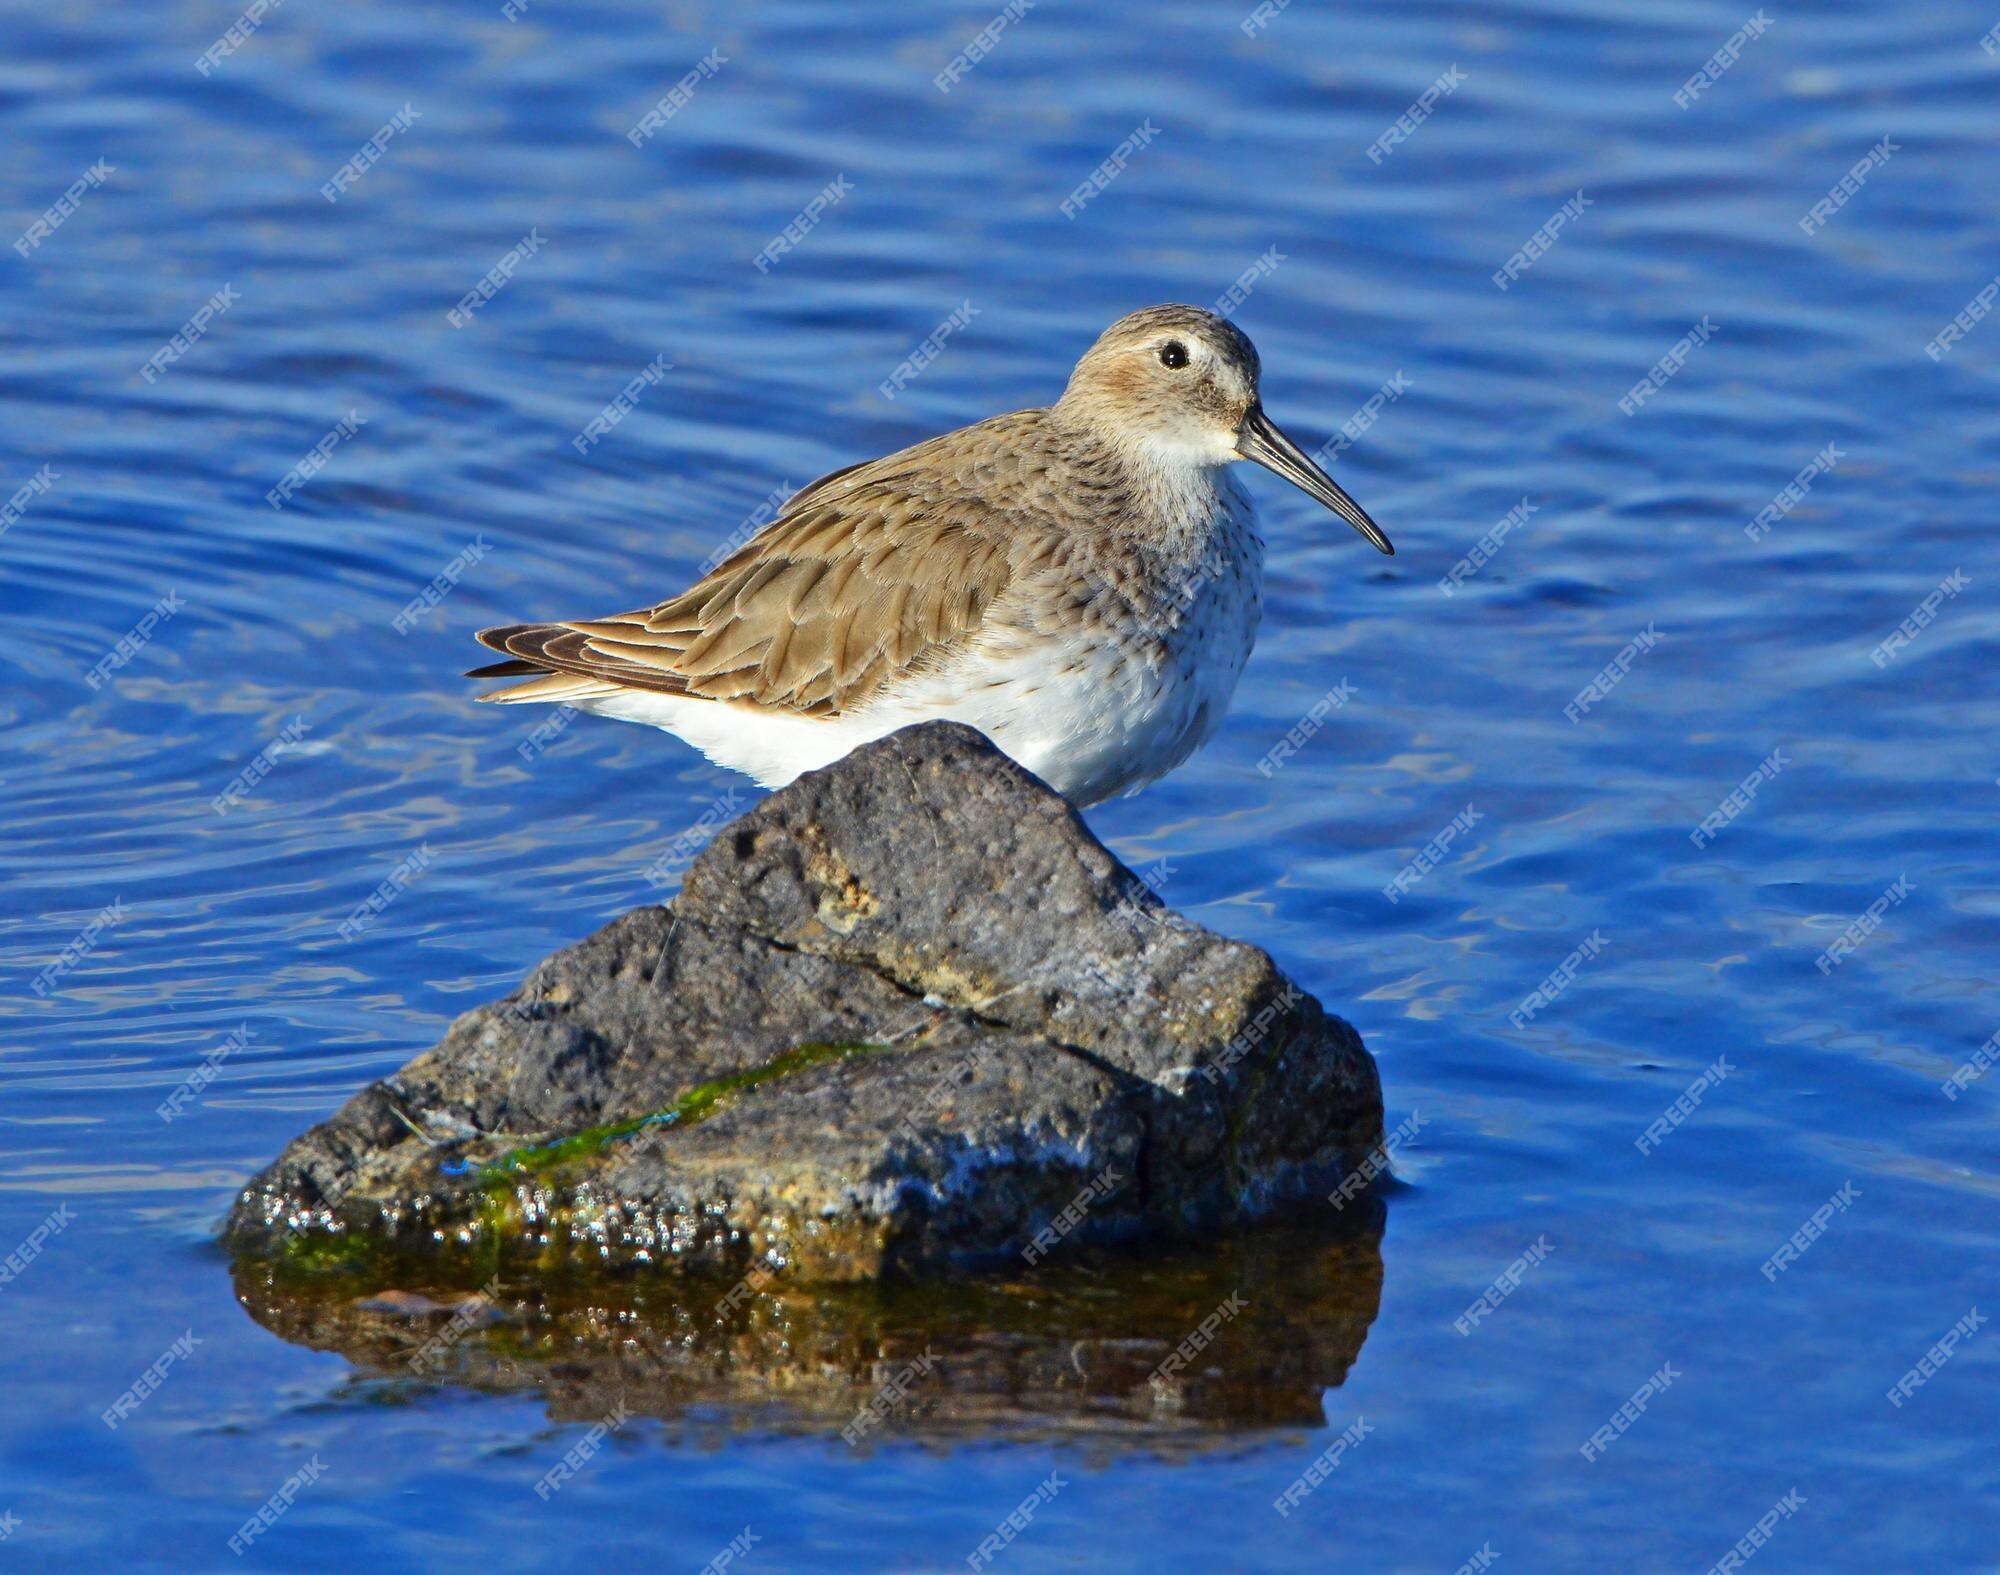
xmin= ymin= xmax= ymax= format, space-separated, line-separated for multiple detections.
xmin=0 ymin=0 xmax=2000 ymax=1571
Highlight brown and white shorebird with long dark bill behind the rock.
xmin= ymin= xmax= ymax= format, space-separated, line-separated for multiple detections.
xmin=468 ymin=306 xmax=1394 ymax=805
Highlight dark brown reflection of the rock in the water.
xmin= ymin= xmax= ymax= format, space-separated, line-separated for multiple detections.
xmin=236 ymin=1227 xmax=1382 ymax=1449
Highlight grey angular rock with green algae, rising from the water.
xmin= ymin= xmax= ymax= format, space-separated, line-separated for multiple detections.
xmin=226 ymin=724 xmax=1382 ymax=1283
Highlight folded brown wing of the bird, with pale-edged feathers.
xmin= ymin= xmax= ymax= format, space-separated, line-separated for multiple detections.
xmin=478 ymin=457 xmax=1010 ymax=718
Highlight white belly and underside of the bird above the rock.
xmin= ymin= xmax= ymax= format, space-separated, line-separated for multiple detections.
xmin=524 ymin=477 xmax=1262 ymax=805
